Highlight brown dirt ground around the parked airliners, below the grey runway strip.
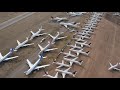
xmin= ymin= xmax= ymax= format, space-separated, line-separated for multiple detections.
xmin=0 ymin=12 xmax=120 ymax=78
